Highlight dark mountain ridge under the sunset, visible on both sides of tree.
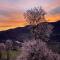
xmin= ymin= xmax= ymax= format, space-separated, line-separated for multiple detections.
xmin=0 ymin=21 xmax=60 ymax=42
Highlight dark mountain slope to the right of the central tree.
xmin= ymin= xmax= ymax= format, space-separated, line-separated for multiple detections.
xmin=50 ymin=21 xmax=60 ymax=42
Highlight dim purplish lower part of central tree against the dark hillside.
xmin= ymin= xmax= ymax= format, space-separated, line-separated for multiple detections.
xmin=32 ymin=23 xmax=54 ymax=42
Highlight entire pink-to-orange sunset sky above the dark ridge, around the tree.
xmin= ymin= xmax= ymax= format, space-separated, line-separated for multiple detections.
xmin=0 ymin=0 xmax=60 ymax=31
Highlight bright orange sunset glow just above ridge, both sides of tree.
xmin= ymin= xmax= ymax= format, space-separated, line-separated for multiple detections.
xmin=0 ymin=14 xmax=60 ymax=30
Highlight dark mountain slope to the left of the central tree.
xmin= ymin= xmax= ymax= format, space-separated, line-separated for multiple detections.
xmin=0 ymin=26 xmax=31 ymax=42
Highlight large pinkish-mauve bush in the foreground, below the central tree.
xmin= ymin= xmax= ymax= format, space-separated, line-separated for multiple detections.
xmin=17 ymin=40 xmax=60 ymax=60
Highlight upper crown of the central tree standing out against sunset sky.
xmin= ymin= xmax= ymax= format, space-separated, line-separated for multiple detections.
xmin=24 ymin=7 xmax=46 ymax=25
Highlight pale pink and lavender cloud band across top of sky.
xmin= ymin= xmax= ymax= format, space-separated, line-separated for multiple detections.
xmin=0 ymin=0 xmax=60 ymax=10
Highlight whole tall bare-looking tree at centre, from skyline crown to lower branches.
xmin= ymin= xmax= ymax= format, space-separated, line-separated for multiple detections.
xmin=24 ymin=7 xmax=53 ymax=41
